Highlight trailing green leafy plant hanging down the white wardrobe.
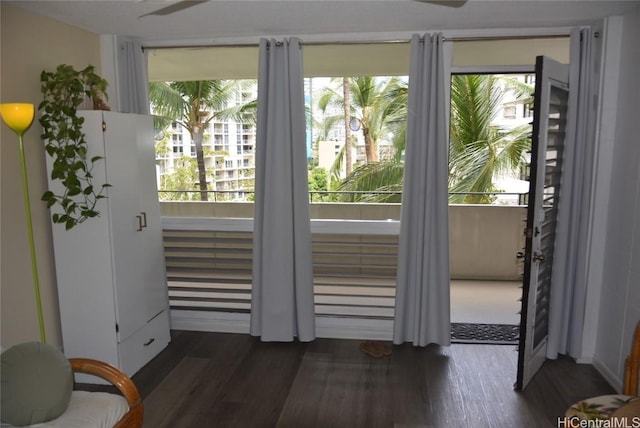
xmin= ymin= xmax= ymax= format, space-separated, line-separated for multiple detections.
xmin=38 ymin=64 xmax=109 ymax=230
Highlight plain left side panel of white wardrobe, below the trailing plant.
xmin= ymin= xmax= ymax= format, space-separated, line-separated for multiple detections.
xmin=53 ymin=111 xmax=118 ymax=366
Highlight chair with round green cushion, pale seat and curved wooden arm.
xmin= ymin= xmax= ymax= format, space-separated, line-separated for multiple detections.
xmin=0 ymin=342 xmax=144 ymax=428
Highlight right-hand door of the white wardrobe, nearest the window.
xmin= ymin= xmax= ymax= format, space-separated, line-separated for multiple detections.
xmin=137 ymin=115 xmax=168 ymax=321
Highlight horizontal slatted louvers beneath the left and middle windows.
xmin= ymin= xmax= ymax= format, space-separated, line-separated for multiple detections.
xmin=164 ymin=218 xmax=398 ymax=319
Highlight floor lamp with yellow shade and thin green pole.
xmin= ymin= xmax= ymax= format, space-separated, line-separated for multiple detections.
xmin=0 ymin=103 xmax=47 ymax=343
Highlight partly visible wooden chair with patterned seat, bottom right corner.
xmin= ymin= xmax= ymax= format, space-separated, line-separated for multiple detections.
xmin=565 ymin=321 xmax=640 ymax=420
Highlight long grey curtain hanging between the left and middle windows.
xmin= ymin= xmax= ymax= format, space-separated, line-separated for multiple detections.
xmin=251 ymin=38 xmax=315 ymax=342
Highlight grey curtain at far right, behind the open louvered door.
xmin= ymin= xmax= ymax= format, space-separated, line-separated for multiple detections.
xmin=547 ymin=28 xmax=595 ymax=358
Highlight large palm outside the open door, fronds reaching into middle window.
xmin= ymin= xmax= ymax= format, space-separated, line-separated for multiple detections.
xmin=340 ymin=75 xmax=531 ymax=203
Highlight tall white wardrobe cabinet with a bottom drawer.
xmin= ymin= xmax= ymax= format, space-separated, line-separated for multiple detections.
xmin=47 ymin=111 xmax=170 ymax=382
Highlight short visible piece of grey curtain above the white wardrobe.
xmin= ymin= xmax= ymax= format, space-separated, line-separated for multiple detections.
xmin=116 ymin=37 xmax=149 ymax=114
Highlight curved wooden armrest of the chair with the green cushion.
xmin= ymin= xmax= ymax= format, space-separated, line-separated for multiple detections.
xmin=69 ymin=358 xmax=144 ymax=427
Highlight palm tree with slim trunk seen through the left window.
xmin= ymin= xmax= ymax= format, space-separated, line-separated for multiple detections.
xmin=149 ymin=80 xmax=256 ymax=201
